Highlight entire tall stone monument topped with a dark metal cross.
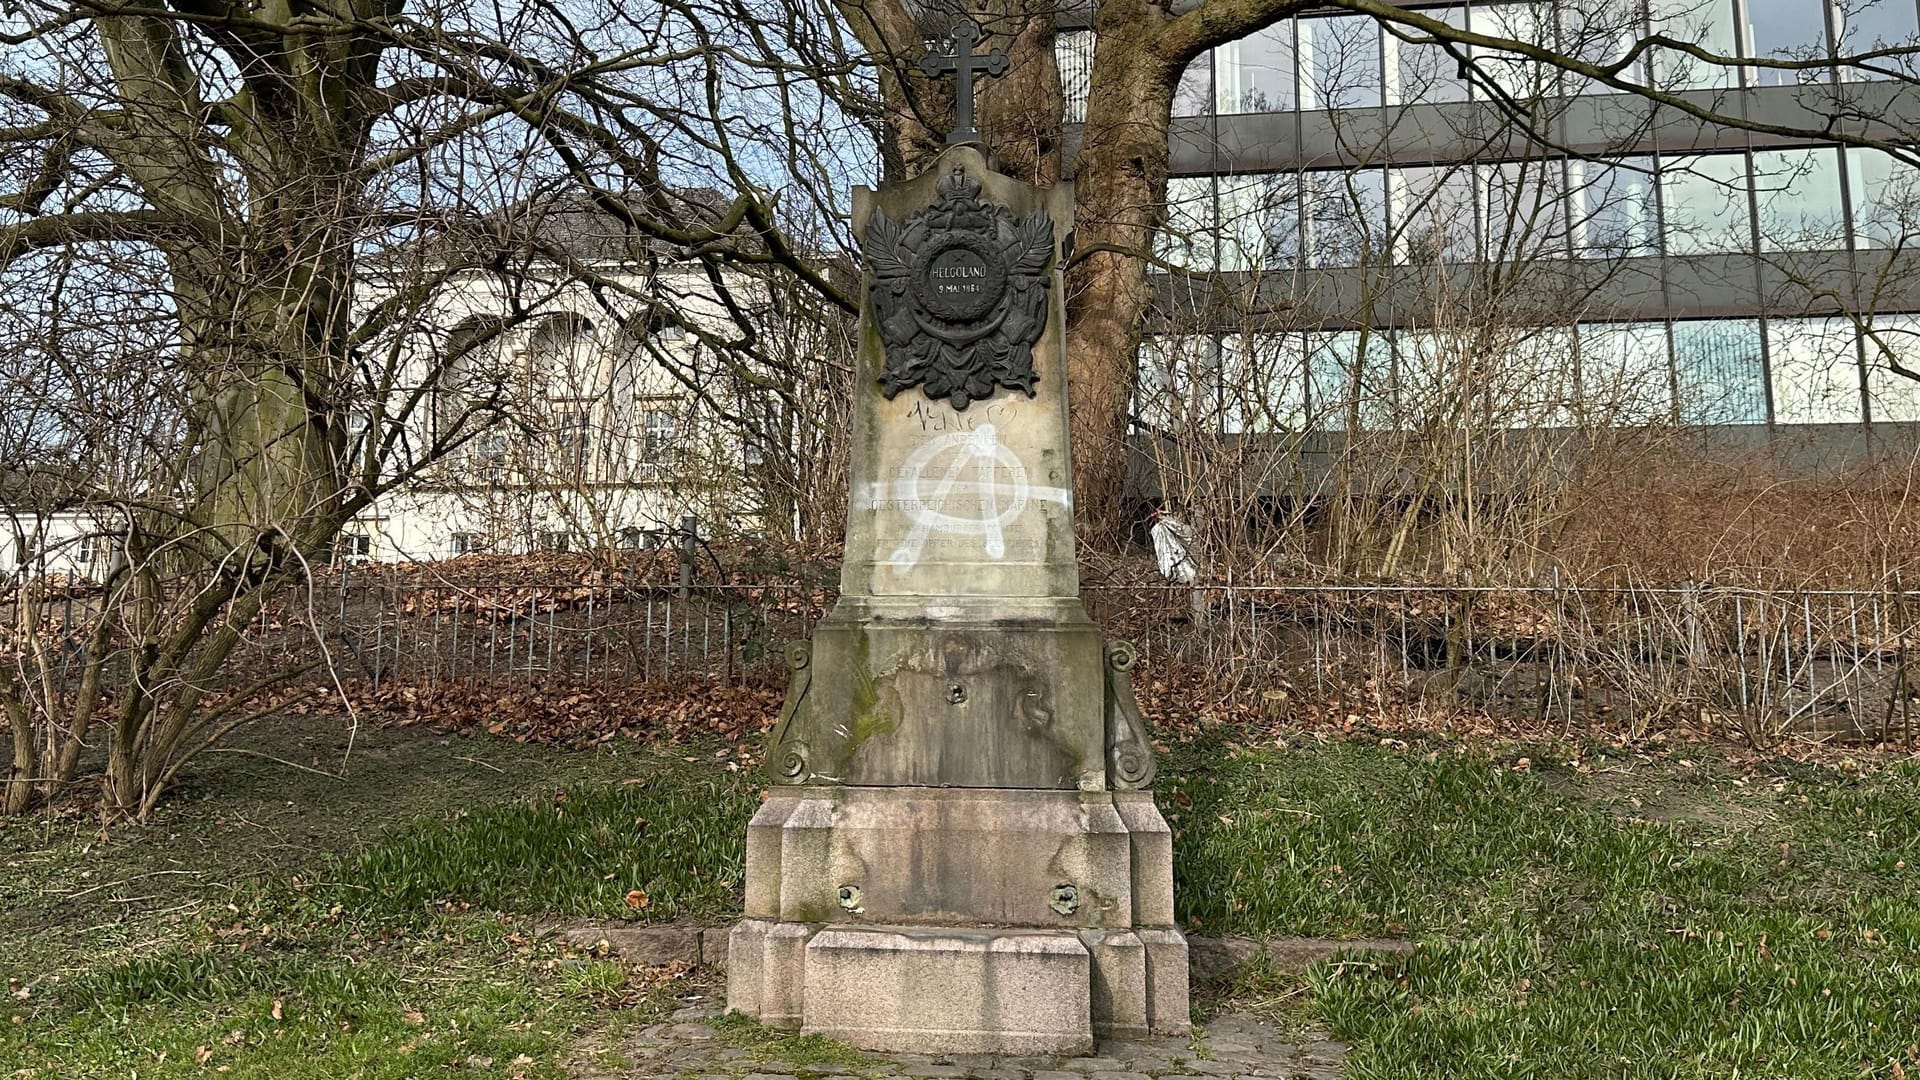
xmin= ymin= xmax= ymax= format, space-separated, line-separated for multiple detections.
xmin=728 ymin=21 xmax=1188 ymax=1053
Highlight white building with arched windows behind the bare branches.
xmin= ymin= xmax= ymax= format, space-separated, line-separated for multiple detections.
xmin=342 ymin=202 xmax=787 ymax=561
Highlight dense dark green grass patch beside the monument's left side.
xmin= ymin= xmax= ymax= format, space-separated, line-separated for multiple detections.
xmin=338 ymin=769 xmax=758 ymax=920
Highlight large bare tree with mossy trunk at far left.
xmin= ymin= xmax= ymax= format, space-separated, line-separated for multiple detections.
xmin=0 ymin=0 xmax=856 ymax=817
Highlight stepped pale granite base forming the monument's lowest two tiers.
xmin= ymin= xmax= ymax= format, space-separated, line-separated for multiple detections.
xmin=728 ymin=788 xmax=1190 ymax=1053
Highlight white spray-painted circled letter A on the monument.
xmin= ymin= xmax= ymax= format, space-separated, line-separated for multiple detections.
xmin=870 ymin=425 xmax=1073 ymax=573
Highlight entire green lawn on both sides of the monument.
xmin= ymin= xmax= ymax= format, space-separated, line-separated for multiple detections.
xmin=0 ymin=711 xmax=1920 ymax=1080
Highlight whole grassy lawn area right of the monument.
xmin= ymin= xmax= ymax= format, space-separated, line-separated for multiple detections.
xmin=1164 ymin=744 xmax=1920 ymax=1080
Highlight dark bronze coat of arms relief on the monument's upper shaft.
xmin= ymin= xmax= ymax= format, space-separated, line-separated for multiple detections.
xmin=866 ymin=165 xmax=1054 ymax=409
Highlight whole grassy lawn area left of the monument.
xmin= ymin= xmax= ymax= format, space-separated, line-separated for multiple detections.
xmin=0 ymin=721 xmax=753 ymax=1080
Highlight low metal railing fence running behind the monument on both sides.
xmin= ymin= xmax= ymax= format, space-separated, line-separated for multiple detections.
xmin=0 ymin=567 xmax=1920 ymax=744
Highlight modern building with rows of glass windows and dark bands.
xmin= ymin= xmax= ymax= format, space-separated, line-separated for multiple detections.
xmin=1060 ymin=0 xmax=1920 ymax=432
